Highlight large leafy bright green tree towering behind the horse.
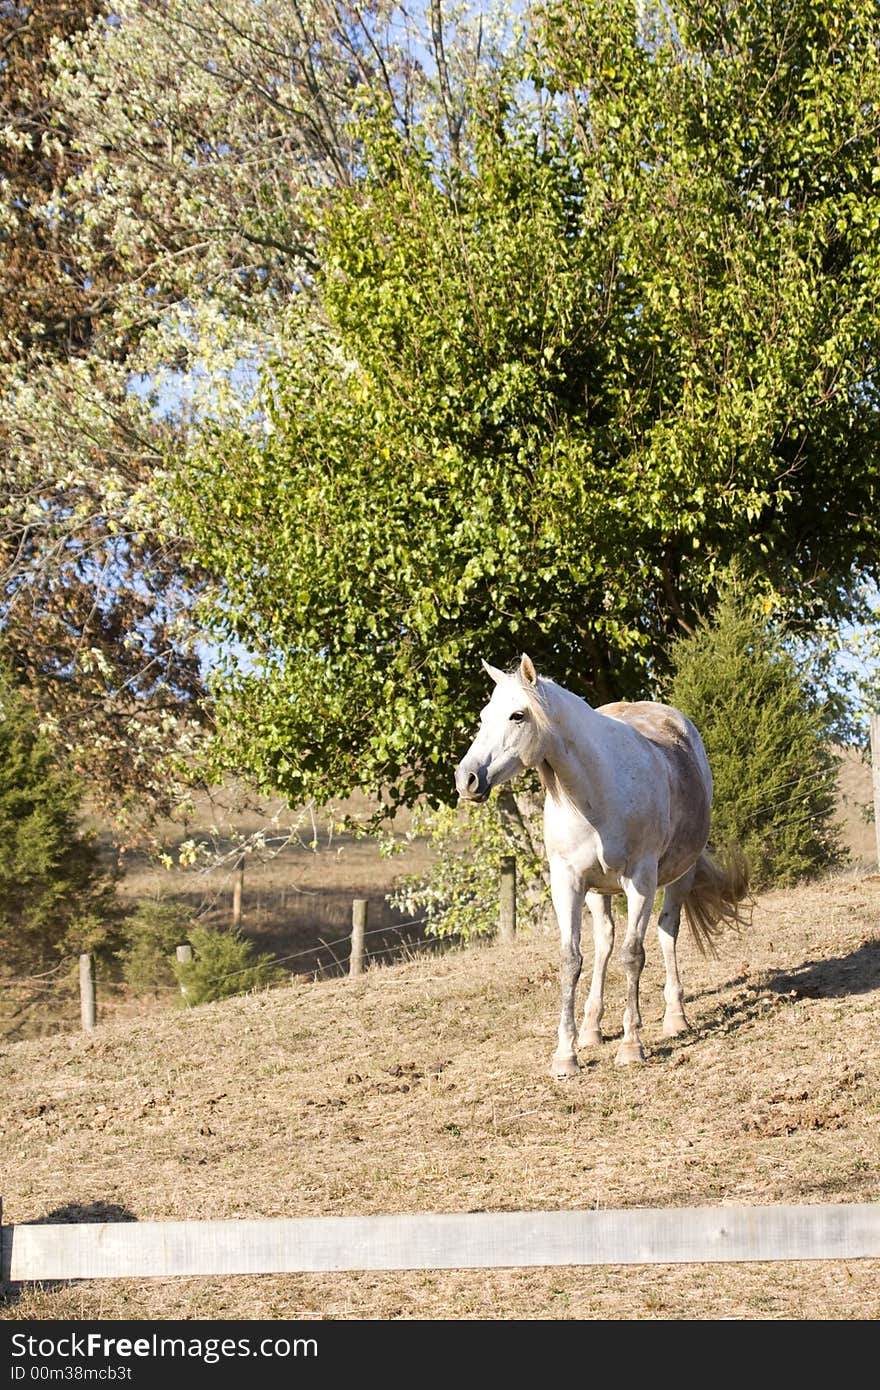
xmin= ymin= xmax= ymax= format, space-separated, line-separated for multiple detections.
xmin=177 ymin=0 xmax=880 ymax=801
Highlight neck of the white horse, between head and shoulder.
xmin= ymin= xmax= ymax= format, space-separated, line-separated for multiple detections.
xmin=538 ymin=685 xmax=610 ymax=812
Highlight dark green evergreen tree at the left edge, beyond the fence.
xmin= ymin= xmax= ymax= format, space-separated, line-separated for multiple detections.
xmin=0 ymin=658 xmax=113 ymax=974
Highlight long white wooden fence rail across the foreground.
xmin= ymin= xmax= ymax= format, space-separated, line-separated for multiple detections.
xmin=0 ymin=1202 xmax=880 ymax=1283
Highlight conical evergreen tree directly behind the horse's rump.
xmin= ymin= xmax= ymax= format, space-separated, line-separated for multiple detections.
xmin=667 ymin=578 xmax=845 ymax=888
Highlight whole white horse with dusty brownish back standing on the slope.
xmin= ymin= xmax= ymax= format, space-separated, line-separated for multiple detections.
xmin=456 ymin=656 xmax=748 ymax=1079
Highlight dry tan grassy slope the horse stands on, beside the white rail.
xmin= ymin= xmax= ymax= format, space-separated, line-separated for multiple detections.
xmin=0 ymin=869 xmax=880 ymax=1321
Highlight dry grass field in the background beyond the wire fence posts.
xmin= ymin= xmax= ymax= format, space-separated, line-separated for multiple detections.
xmin=0 ymin=792 xmax=432 ymax=1041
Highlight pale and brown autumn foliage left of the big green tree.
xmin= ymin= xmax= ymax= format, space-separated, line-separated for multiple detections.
xmin=0 ymin=0 xmax=428 ymax=833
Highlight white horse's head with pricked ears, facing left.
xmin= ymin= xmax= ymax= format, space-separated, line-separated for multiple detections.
xmin=455 ymin=656 xmax=545 ymax=801
